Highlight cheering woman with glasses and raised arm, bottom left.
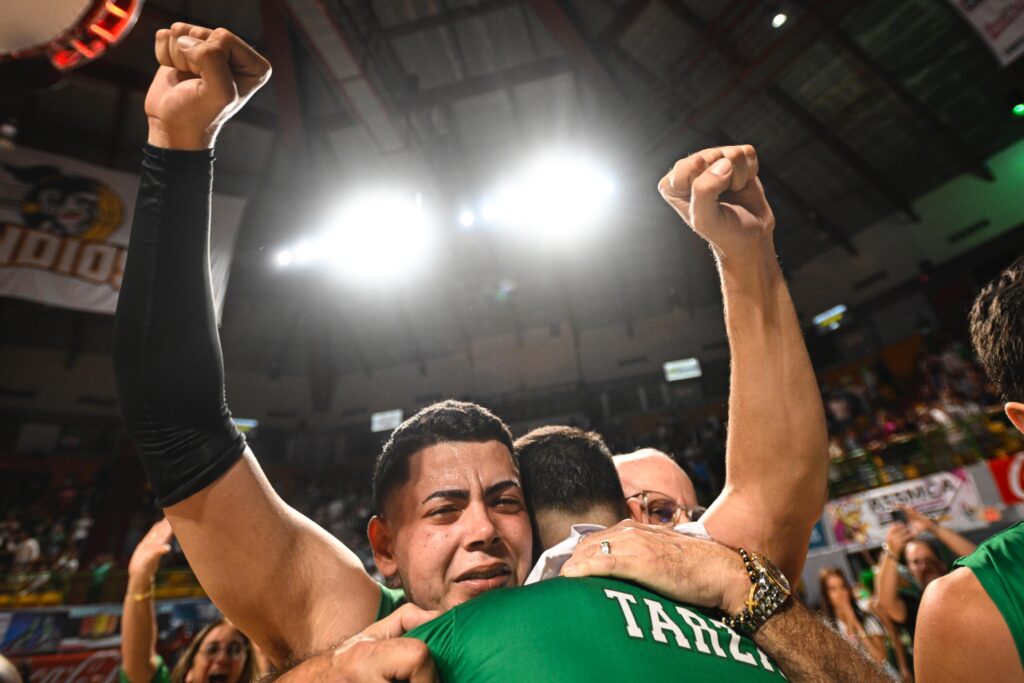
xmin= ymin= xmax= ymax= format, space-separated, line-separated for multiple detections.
xmin=121 ymin=519 xmax=254 ymax=683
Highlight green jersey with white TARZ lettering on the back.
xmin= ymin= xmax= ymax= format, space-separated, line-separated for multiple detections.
xmin=408 ymin=578 xmax=784 ymax=683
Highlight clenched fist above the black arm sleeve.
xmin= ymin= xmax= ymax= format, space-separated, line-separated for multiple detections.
xmin=145 ymin=23 xmax=270 ymax=150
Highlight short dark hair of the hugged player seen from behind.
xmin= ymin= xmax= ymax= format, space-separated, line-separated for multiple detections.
xmin=515 ymin=426 xmax=629 ymax=516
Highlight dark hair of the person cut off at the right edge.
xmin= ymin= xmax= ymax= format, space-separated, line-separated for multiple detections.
xmin=971 ymin=256 xmax=1024 ymax=400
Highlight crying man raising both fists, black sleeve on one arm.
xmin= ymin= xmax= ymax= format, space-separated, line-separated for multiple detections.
xmin=115 ymin=24 xmax=827 ymax=678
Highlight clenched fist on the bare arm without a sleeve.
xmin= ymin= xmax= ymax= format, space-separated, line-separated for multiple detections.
xmin=657 ymin=144 xmax=775 ymax=259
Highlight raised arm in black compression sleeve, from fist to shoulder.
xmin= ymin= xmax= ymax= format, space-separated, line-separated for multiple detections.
xmin=114 ymin=24 xmax=380 ymax=664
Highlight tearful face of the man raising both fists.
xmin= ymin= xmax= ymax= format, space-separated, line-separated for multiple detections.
xmin=378 ymin=441 xmax=532 ymax=610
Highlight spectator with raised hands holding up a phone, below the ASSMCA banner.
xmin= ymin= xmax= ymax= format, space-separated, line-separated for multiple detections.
xmin=876 ymin=505 xmax=976 ymax=638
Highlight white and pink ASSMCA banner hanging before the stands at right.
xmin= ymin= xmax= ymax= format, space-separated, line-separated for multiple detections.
xmin=824 ymin=467 xmax=988 ymax=546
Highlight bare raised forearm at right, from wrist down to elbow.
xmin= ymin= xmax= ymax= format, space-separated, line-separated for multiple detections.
xmin=719 ymin=240 xmax=827 ymax=575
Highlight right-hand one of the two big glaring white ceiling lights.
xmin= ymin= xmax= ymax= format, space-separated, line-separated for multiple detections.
xmin=498 ymin=155 xmax=614 ymax=242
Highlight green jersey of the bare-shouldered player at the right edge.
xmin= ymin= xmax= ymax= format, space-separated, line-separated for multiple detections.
xmin=954 ymin=522 xmax=1024 ymax=664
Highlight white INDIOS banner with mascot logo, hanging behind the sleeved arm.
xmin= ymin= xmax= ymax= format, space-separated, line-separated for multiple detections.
xmin=0 ymin=148 xmax=245 ymax=319
